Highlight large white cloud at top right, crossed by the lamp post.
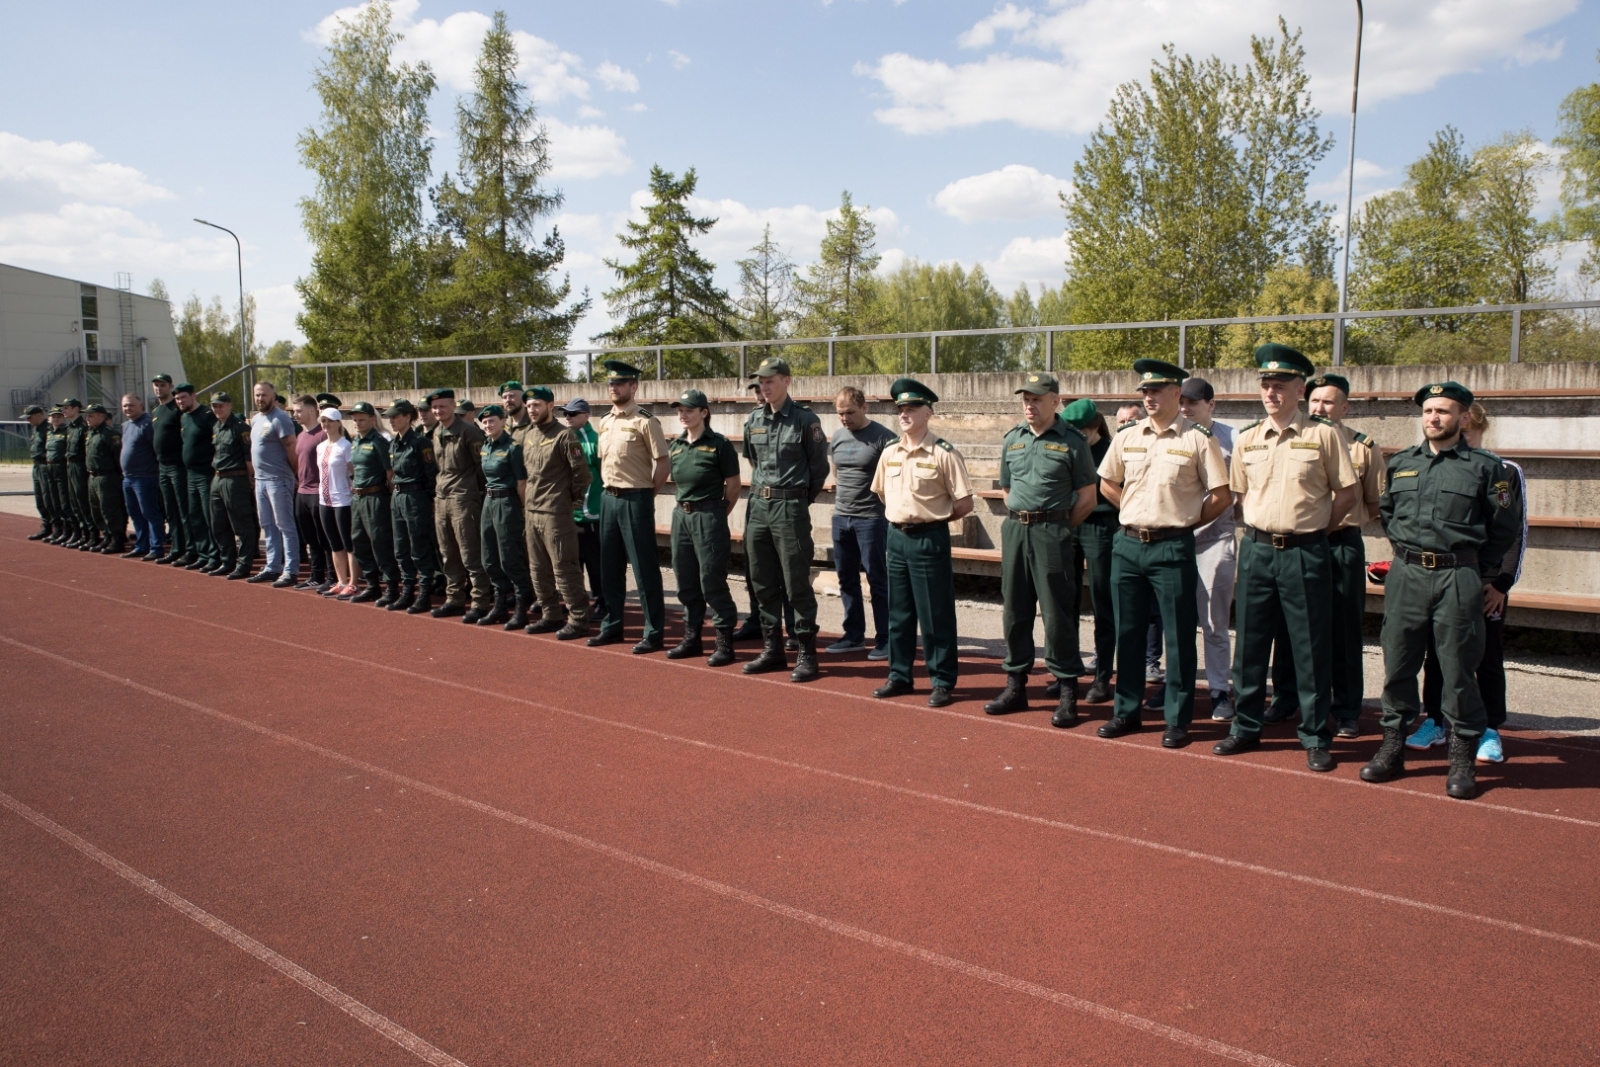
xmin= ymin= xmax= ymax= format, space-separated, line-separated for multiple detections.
xmin=858 ymin=0 xmax=1578 ymax=133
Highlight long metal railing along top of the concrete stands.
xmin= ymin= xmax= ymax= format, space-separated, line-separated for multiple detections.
xmin=202 ymin=301 xmax=1600 ymax=392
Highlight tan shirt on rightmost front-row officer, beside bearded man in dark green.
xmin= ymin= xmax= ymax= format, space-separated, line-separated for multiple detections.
xmin=1232 ymin=411 xmax=1355 ymax=534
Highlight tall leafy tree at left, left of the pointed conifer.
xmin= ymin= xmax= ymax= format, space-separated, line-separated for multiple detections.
xmin=296 ymin=0 xmax=435 ymax=360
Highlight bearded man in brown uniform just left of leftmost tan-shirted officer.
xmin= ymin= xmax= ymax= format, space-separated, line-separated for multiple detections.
xmin=512 ymin=386 xmax=589 ymax=641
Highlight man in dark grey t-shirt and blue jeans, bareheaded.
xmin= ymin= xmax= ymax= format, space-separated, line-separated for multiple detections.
xmin=824 ymin=386 xmax=894 ymax=659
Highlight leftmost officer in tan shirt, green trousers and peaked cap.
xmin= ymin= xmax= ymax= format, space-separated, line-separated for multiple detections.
xmin=586 ymin=360 xmax=669 ymax=656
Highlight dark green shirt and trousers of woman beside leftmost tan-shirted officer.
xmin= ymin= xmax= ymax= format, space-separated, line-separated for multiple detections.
xmin=667 ymin=426 xmax=739 ymax=633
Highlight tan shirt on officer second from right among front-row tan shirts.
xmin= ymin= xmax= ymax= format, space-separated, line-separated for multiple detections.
xmin=1099 ymin=416 xmax=1237 ymax=530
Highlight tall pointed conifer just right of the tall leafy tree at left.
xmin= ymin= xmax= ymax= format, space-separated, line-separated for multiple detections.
xmin=427 ymin=11 xmax=589 ymax=381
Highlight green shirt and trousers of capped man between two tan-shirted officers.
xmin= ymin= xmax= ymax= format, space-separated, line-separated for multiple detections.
xmin=1000 ymin=418 xmax=1098 ymax=680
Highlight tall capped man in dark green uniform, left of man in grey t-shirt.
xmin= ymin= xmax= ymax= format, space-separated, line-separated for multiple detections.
xmin=744 ymin=355 xmax=829 ymax=681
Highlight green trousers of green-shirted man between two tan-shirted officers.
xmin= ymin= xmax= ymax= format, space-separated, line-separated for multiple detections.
xmin=1000 ymin=518 xmax=1083 ymax=678
